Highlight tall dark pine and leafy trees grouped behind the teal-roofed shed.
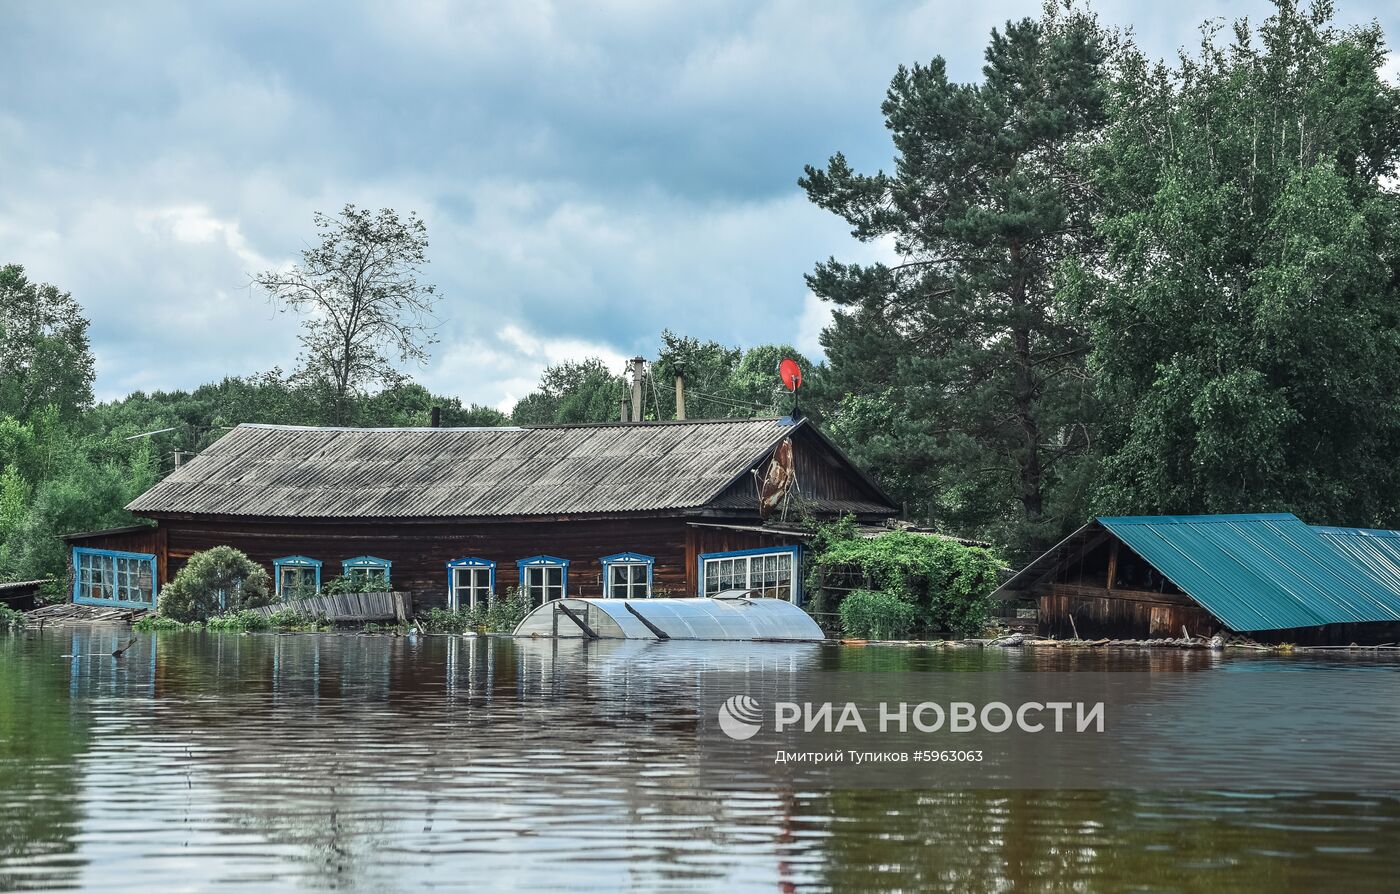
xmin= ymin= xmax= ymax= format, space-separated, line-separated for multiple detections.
xmin=801 ymin=0 xmax=1400 ymax=560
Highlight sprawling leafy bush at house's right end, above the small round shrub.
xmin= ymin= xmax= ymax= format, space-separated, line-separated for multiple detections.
xmin=808 ymin=519 xmax=1001 ymax=637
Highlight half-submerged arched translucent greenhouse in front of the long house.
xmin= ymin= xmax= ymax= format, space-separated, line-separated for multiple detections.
xmin=515 ymin=592 xmax=825 ymax=642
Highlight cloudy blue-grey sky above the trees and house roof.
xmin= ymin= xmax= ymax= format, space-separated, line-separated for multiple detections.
xmin=0 ymin=0 xmax=1400 ymax=409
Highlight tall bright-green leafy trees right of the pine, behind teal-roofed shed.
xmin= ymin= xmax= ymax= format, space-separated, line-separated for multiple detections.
xmin=1075 ymin=0 xmax=1400 ymax=527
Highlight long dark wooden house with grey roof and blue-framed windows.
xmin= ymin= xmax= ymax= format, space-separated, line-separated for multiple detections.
xmin=67 ymin=418 xmax=896 ymax=607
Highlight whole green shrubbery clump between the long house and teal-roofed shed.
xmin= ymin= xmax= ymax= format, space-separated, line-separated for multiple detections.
xmin=808 ymin=519 xmax=1001 ymax=639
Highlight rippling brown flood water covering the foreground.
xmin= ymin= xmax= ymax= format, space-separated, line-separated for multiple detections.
xmin=0 ymin=627 xmax=1400 ymax=891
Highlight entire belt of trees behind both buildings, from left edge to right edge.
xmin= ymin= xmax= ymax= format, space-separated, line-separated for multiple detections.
xmin=0 ymin=0 xmax=1400 ymax=579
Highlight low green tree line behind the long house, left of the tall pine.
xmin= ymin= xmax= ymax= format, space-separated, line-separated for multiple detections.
xmin=0 ymin=251 xmax=801 ymax=597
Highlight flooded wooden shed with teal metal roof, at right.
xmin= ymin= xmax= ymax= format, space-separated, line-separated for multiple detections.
xmin=993 ymin=513 xmax=1400 ymax=645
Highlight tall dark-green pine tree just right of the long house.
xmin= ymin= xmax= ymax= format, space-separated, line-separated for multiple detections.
xmin=799 ymin=4 xmax=1113 ymax=554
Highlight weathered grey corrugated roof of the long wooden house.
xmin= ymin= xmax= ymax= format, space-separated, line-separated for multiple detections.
xmin=127 ymin=418 xmax=805 ymax=518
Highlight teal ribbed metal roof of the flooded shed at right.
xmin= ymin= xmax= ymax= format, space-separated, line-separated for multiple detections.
xmin=1098 ymin=512 xmax=1400 ymax=631
